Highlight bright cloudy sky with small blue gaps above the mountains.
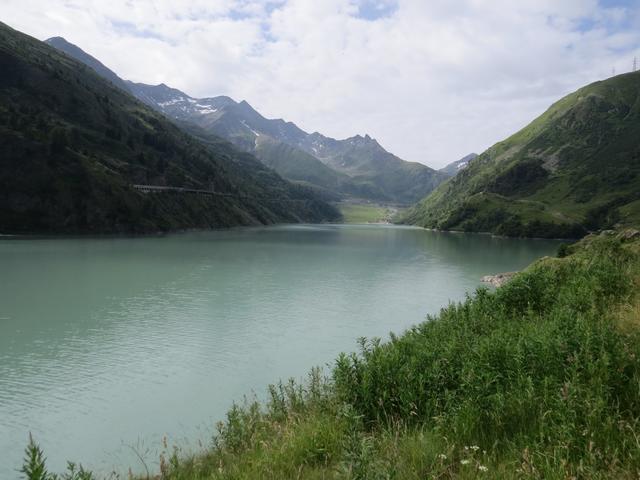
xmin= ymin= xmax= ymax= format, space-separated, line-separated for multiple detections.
xmin=0 ymin=0 xmax=640 ymax=168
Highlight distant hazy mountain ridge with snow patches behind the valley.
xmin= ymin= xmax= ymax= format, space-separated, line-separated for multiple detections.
xmin=48 ymin=37 xmax=447 ymax=203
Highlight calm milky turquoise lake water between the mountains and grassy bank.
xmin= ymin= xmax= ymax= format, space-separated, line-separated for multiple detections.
xmin=0 ymin=225 xmax=557 ymax=479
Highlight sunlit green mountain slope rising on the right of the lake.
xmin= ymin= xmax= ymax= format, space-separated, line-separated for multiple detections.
xmin=404 ymin=72 xmax=640 ymax=237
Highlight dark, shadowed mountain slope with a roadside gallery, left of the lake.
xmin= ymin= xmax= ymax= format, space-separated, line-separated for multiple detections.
xmin=0 ymin=23 xmax=338 ymax=233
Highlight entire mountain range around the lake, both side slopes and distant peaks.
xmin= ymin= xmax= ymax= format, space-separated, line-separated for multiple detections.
xmin=0 ymin=24 xmax=640 ymax=237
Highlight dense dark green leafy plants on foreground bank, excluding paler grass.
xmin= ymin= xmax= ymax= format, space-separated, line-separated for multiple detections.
xmin=334 ymin=235 xmax=640 ymax=477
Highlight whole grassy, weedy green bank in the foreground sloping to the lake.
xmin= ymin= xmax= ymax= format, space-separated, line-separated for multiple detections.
xmin=29 ymin=231 xmax=640 ymax=480
